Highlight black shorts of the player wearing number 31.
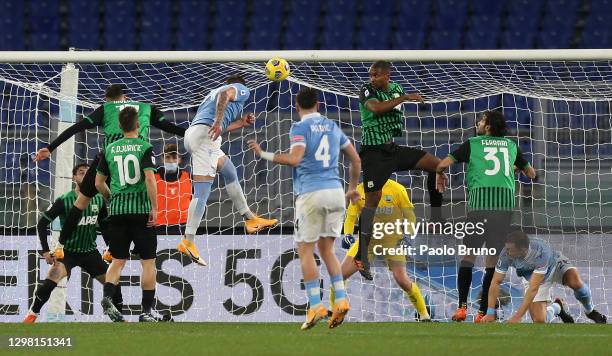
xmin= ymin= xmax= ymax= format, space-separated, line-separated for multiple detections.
xmin=463 ymin=210 xmax=512 ymax=256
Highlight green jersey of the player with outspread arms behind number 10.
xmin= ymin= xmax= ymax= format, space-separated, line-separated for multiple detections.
xmin=85 ymin=101 xmax=164 ymax=147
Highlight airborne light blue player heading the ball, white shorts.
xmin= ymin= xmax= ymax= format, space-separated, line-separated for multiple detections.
xmin=178 ymin=75 xmax=278 ymax=266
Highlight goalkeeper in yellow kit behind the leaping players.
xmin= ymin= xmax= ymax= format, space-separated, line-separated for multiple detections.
xmin=330 ymin=179 xmax=431 ymax=321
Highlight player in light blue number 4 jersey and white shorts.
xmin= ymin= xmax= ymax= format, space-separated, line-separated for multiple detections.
xmin=249 ymin=88 xmax=361 ymax=330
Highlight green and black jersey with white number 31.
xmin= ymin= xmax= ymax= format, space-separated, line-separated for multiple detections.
xmin=449 ymin=135 xmax=529 ymax=210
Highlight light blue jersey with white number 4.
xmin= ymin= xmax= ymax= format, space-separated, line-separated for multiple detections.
xmin=289 ymin=113 xmax=350 ymax=195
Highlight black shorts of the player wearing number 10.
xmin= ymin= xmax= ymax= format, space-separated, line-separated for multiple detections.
xmin=109 ymin=214 xmax=157 ymax=260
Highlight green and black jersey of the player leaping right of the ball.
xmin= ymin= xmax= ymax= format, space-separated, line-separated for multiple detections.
xmin=359 ymin=82 xmax=404 ymax=146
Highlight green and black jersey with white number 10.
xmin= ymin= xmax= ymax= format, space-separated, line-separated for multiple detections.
xmin=98 ymin=138 xmax=155 ymax=216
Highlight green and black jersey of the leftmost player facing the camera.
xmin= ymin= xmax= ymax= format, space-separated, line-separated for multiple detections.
xmin=38 ymin=190 xmax=108 ymax=252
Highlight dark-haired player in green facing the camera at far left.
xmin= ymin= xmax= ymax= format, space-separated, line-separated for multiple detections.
xmin=23 ymin=163 xmax=123 ymax=323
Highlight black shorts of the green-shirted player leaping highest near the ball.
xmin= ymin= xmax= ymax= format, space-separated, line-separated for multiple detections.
xmin=359 ymin=142 xmax=427 ymax=192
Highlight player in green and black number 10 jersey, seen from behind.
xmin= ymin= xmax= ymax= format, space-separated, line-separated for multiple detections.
xmin=96 ymin=107 xmax=157 ymax=322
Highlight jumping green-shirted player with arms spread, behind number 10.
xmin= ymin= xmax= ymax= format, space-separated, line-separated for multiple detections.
xmin=35 ymin=84 xmax=185 ymax=262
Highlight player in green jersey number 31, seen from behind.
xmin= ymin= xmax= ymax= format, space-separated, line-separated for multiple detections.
xmin=436 ymin=111 xmax=536 ymax=322
